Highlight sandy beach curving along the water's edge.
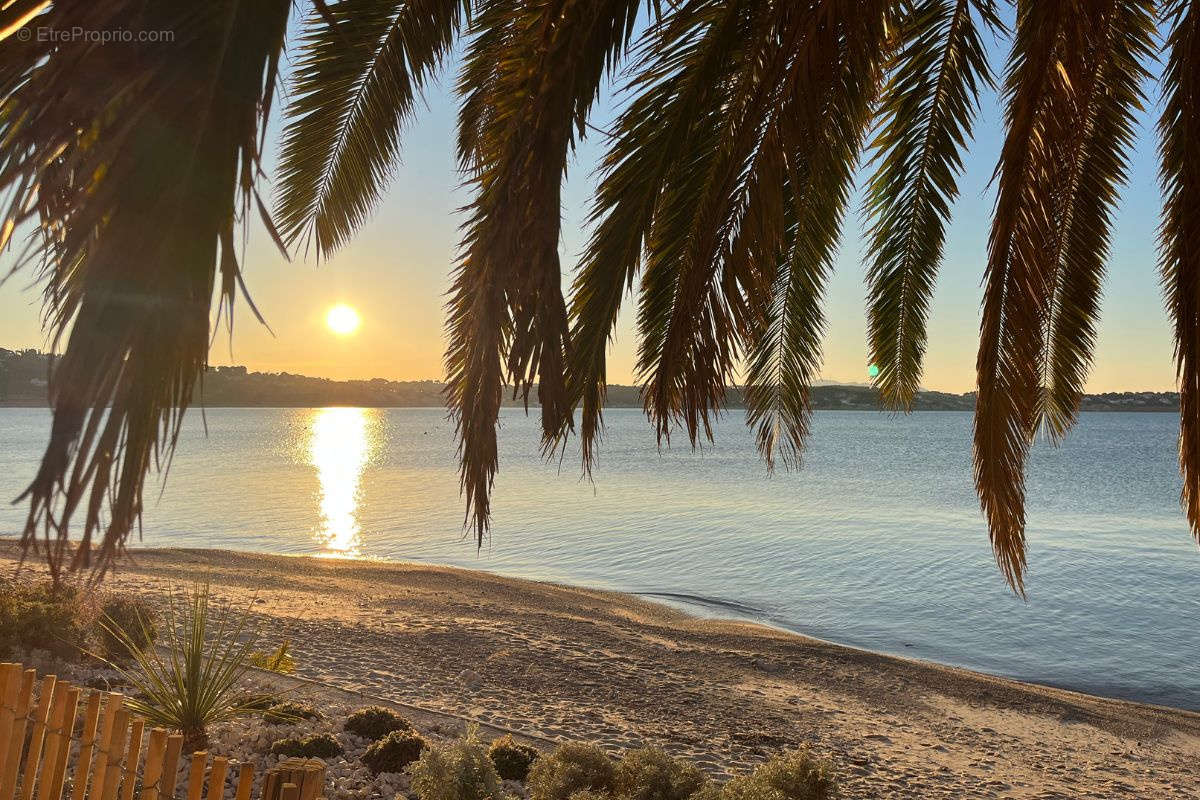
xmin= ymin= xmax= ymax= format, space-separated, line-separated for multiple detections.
xmin=2 ymin=546 xmax=1200 ymax=800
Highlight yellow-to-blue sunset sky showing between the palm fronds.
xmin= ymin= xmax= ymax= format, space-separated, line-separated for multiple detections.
xmin=0 ymin=7 xmax=1175 ymax=392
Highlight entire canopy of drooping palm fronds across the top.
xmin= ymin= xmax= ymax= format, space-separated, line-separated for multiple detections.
xmin=0 ymin=0 xmax=1200 ymax=590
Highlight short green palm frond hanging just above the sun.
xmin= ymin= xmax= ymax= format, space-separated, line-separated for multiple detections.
xmin=276 ymin=0 xmax=467 ymax=255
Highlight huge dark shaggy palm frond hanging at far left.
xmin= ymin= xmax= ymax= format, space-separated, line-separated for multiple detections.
xmin=0 ymin=0 xmax=290 ymax=576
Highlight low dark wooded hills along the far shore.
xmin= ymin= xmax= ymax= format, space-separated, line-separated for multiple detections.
xmin=0 ymin=349 xmax=1180 ymax=411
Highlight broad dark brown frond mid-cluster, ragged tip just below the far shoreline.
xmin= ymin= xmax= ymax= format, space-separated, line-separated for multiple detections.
xmin=636 ymin=4 xmax=812 ymax=446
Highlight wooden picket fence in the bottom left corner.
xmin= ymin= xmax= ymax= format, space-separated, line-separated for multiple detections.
xmin=0 ymin=663 xmax=325 ymax=800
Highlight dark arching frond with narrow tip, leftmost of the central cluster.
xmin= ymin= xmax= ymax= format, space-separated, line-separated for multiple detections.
xmin=568 ymin=0 xmax=752 ymax=470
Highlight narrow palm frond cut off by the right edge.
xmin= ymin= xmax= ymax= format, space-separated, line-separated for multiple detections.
xmin=1158 ymin=0 xmax=1200 ymax=541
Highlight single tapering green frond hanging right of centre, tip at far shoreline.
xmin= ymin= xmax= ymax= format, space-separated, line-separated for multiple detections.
xmin=865 ymin=0 xmax=1001 ymax=410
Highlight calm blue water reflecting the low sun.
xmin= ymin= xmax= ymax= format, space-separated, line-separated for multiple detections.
xmin=0 ymin=409 xmax=1200 ymax=709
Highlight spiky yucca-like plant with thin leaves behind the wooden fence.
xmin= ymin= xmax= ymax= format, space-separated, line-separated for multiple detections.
xmin=102 ymin=584 xmax=265 ymax=752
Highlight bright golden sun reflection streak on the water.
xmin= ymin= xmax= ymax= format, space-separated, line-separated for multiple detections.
xmin=308 ymin=408 xmax=379 ymax=558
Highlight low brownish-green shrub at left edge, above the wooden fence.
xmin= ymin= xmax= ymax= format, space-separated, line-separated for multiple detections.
xmin=0 ymin=578 xmax=92 ymax=658
